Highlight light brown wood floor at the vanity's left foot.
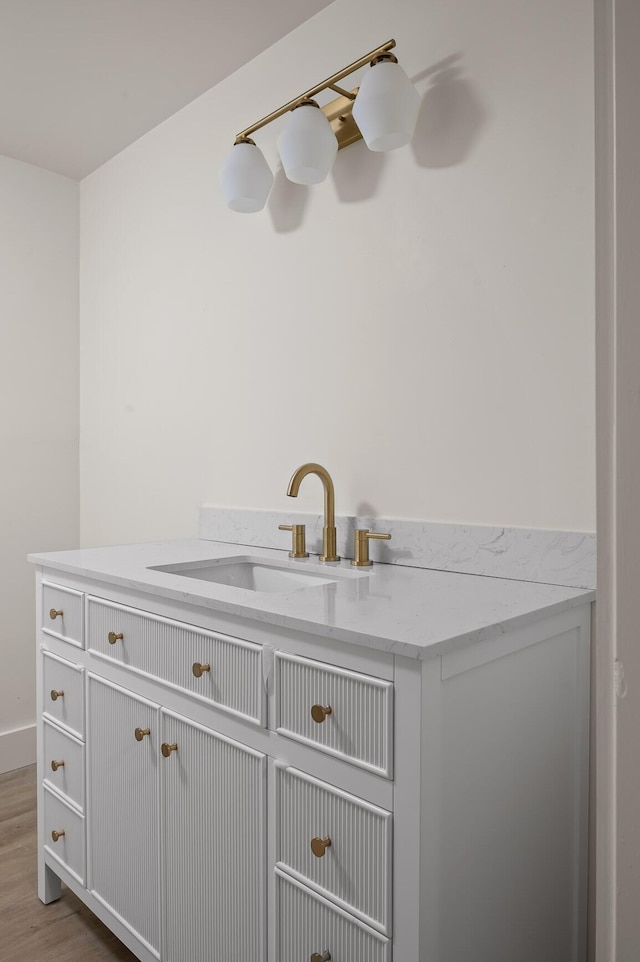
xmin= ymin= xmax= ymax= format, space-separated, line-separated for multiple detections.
xmin=0 ymin=765 xmax=136 ymax=962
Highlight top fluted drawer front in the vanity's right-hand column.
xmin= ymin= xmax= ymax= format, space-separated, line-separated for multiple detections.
xmin=276 ymin=652 xmax=393 ymax=778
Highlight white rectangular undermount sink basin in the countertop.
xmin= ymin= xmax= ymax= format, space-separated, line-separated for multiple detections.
xmin=151 ymin=557 xmax=346 ymax=592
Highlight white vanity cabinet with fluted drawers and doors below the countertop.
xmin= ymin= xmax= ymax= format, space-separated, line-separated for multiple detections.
xmin=32 ymin=567 xmax=590 ymax=962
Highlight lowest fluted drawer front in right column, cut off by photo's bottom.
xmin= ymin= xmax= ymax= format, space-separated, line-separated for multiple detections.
xmin=276 ymin=869 xmax=391 ymax=962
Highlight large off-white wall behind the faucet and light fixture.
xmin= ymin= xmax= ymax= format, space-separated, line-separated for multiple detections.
xmin=81 ymin=0 xmax=595 ymax=544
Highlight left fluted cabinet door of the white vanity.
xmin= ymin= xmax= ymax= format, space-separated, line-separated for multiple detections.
xmin=87 ymin=675 xmax=160 ymax=957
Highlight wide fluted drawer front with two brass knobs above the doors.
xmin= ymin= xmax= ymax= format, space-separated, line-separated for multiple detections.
xmin=87 ymin=597 xmax=266 ymax=725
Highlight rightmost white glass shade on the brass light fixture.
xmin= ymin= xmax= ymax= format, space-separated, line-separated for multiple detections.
xmin=353 ymin=60 xmax=420 ymax=150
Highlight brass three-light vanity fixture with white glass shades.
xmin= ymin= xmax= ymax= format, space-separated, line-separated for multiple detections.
xmin=220 ymin=40 xmax=420 ymax=213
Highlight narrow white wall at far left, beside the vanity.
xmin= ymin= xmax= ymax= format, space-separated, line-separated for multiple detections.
xmin=0 ymin=157 xmax=79 ymax=772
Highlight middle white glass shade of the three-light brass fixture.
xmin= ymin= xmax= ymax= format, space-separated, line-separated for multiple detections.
xmin=278 ymin=104 xmax=338 ymax=184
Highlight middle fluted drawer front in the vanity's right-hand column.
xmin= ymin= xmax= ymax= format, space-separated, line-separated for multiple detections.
xmin=276 ymin=765 xmax=392 ymax=935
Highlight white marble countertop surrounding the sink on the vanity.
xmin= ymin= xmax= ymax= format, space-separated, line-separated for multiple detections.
xmin=29 ymin=539 xmax=595 ymax=658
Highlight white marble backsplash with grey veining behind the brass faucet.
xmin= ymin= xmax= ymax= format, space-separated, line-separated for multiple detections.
xmin=199 ymin=505 xmax=596 ymax=588
